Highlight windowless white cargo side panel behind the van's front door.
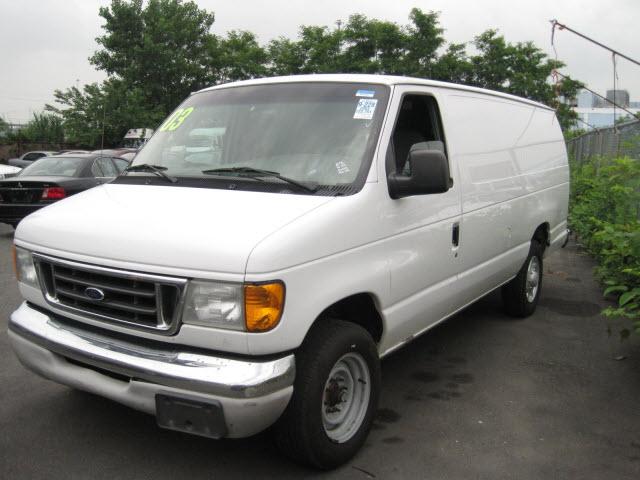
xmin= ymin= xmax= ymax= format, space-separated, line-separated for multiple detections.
xmin=443 ymin=92 xmax=568 ymax=303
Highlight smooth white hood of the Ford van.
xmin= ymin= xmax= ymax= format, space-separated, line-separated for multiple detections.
xmin=15 ymin=184 xmax=334 ymax=274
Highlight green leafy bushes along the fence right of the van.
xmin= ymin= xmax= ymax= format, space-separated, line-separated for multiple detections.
xmin=570 ymin=158 xmax=640 ymax=333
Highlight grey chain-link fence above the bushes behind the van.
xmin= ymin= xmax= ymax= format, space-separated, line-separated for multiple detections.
xmin=567 ymin=120 xmax=640 ymax=163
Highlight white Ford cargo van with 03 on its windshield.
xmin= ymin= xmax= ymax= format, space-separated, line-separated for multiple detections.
xmin=9 ymin=75 xmax=569 ymax=468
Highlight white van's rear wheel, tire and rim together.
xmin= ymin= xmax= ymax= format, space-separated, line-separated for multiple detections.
xmin=502 ymin=239 xmax=544 ymax=318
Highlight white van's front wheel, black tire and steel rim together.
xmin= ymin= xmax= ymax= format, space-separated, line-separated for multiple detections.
xmin=275 ymin=319 xmax=380 ymax=470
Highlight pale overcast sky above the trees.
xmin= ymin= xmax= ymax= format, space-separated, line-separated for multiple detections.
xmin=0 ymin=0 xmax=640 ymax=122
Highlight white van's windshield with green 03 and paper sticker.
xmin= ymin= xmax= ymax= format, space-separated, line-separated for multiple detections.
xmin=130 ymin=82 xmax=389 ymax=193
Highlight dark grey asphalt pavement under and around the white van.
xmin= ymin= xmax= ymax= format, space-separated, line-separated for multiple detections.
xmin=0 ymin=224 xmax=640 ymax=480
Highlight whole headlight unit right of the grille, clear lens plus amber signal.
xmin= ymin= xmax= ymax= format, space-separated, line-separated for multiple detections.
xmin=182 ymin=280 xmax=285 ymax=332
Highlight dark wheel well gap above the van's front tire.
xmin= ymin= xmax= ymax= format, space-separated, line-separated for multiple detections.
xmin=316 ymin=293 xmax=383 ymax=343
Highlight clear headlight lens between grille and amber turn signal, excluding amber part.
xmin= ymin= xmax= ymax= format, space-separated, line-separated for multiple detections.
xmin=182 ymin=280 xmax=244 ymax=330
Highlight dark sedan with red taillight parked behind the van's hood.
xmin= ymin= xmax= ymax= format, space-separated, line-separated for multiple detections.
xmin=0 ymin=154 xmax=129 ymax=227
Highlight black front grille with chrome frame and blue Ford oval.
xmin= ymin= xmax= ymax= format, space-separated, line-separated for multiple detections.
xmin=34 ymin=254 xmax=186 ymax=334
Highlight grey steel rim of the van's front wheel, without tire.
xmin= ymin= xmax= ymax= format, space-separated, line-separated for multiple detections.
xmin=321 ymin=352 xmax=371 ymax=443
